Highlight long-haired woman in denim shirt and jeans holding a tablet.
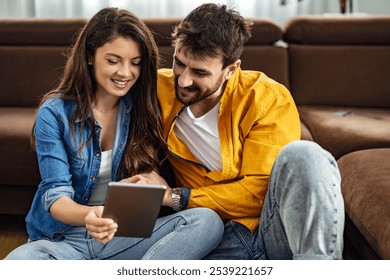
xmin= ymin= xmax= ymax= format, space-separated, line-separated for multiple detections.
xmin=7 ymin=8 xmax=223 ymax=259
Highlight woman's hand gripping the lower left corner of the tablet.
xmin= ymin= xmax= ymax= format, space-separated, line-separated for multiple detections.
xmin=85 ymin=206 xmax=118 ymax=243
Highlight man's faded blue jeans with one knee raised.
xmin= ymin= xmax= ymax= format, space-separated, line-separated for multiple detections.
xmin=205 ymin=141 xmax=344 ymax=260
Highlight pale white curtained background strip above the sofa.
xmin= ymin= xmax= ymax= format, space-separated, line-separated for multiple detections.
xmin=0 ymin=0 xmax=390 ymax=23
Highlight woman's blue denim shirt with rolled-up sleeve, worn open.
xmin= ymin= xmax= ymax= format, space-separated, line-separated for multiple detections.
xmin=26 ymin=94 xmax=132 ymax=240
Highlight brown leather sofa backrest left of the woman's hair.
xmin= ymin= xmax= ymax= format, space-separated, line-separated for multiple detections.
xmin=0 ymin=19 xmax=86 ymax=107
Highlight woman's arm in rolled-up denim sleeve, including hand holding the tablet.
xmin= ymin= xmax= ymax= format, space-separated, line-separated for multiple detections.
xmin=34 ymin=100 xmax=117 ymax=242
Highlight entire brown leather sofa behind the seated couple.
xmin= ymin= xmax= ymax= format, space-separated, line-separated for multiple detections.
xmin=0 ymin=16 xmax=390 ymax=259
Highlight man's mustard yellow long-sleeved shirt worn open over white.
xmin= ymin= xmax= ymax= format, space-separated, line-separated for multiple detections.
xmin=157 ymin=69 xmax=301 ymax=231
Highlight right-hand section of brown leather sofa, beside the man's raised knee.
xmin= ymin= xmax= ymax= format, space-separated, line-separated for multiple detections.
xmin=284 ymin=16 xmax=390 ymax=259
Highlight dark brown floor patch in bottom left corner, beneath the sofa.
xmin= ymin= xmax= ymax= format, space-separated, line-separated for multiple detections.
xmin=0 ymin=215 xmax=27 ymax=259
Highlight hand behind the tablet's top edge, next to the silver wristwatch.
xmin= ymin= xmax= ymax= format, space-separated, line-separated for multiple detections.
xmin=121 ymin=171 xmax=172 ymax=207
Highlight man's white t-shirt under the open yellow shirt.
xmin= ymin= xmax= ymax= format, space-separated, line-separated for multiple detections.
xmin=174 ymin=102 xmax=222 ymax=171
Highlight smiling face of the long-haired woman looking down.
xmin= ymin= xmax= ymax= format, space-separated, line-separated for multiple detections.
xmin=93 ymin=37 xmax=142 ymax=97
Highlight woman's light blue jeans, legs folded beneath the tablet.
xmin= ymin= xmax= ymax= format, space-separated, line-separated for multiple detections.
xmin=6 ymin=208 xmax=223 ymax=260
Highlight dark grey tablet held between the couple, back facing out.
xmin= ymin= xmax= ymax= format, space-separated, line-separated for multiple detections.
xmin=103 ymin=182 xmax=167 ymax=238
